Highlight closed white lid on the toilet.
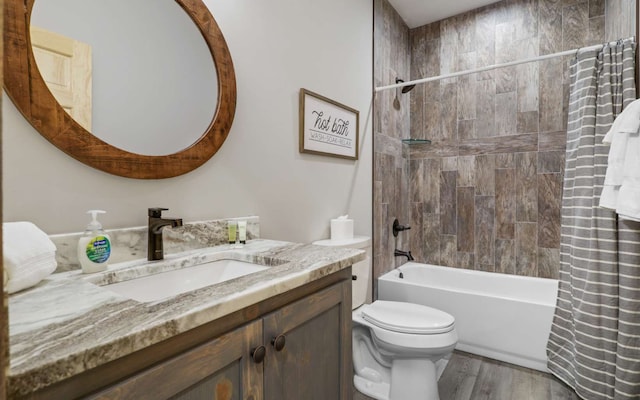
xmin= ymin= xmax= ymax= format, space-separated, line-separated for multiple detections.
xmin=362 ymin=300 xmax=455 ymax=335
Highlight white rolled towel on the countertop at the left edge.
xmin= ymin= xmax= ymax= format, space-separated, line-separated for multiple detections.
xmin=2 ymin=222 xmax=57 ymax=293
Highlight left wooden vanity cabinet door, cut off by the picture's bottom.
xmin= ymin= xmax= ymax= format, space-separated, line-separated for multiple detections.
xmin=89 ymin=320 xmax=263 ymax=400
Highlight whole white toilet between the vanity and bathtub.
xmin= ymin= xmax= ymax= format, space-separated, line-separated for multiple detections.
xmin=314 ymin=236 xmax=458 ymax=400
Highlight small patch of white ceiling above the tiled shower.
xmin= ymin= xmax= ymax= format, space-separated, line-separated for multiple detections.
xmin=389 ymin=0 xmax=498 ymax=28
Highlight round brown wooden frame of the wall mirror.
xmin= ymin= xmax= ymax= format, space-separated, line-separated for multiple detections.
xmin=4 ymin=0 xmax=236 ymax=179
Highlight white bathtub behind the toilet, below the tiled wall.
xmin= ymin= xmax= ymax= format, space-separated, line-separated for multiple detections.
xmin=378 ymin=262 xmax=558 ymax=371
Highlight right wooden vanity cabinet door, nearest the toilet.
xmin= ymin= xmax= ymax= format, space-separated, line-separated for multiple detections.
xmin=264 ymin=281 xmax=353 ymax=400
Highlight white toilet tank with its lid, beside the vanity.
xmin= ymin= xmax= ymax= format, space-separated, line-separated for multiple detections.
xmin=313 ymin=236 xmax=371 ymax=310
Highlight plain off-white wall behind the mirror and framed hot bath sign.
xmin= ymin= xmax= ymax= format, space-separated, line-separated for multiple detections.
xmin=3 ymin=0 xmax=373 ymax=242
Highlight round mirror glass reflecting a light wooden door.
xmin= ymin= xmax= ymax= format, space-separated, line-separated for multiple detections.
xmin=31 ymin=0 xmax=218 ymax=156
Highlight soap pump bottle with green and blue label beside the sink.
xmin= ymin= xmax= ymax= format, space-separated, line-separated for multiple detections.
xmin=78 ymin=210 xmax=111 ymax=274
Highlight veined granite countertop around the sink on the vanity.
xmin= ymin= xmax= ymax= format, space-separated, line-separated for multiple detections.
xmin=9 ymin=239 xmax=365 ymax=397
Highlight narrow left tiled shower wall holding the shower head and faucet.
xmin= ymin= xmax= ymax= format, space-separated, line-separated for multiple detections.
xmin=373 ymin=0 xmax=411 ymax=299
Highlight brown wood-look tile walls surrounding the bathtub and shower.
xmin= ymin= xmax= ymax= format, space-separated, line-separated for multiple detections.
xmin=374 ymin=0 xmax=635 ymax=288
